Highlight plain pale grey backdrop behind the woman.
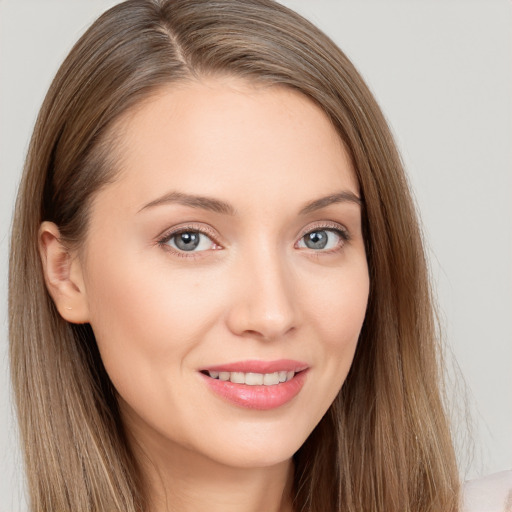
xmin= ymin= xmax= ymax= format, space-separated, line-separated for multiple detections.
xmin=0 ymin=0 xmax=512 ymax=512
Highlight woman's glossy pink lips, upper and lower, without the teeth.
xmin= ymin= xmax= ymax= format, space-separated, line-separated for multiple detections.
xmin=199 ymin=359 xmax=309 ymax=411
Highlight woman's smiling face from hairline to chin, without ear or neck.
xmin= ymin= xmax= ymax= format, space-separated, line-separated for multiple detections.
xmin=80 ymin=79 xmax=369 ymax=467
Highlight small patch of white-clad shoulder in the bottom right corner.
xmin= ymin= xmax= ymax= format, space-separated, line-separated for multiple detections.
xmin=462 ymin=470 xmax=512 ymax=512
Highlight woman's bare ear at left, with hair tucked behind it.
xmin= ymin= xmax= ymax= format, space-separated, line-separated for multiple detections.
xmin=39 ymin=221 xmax=89 ymax=324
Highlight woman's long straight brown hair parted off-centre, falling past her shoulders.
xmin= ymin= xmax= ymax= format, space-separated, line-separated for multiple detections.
xmin=9 ymin=0 xmax=459 ymax=512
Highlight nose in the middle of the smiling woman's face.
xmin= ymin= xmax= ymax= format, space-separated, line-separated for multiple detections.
xmin=227 ymin=250 xmax=298 ymax=340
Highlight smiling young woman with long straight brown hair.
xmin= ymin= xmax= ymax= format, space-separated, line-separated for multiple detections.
xmin=9 ymin=0 xmax=459 ymax=512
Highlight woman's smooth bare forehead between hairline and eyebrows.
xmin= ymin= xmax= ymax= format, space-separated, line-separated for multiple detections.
xmin=99 ymin=78 xmax=358 ymax=212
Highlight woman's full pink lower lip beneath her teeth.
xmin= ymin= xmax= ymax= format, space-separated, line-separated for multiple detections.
xmin=201 ymin=370 xmax=307 ymax=411
